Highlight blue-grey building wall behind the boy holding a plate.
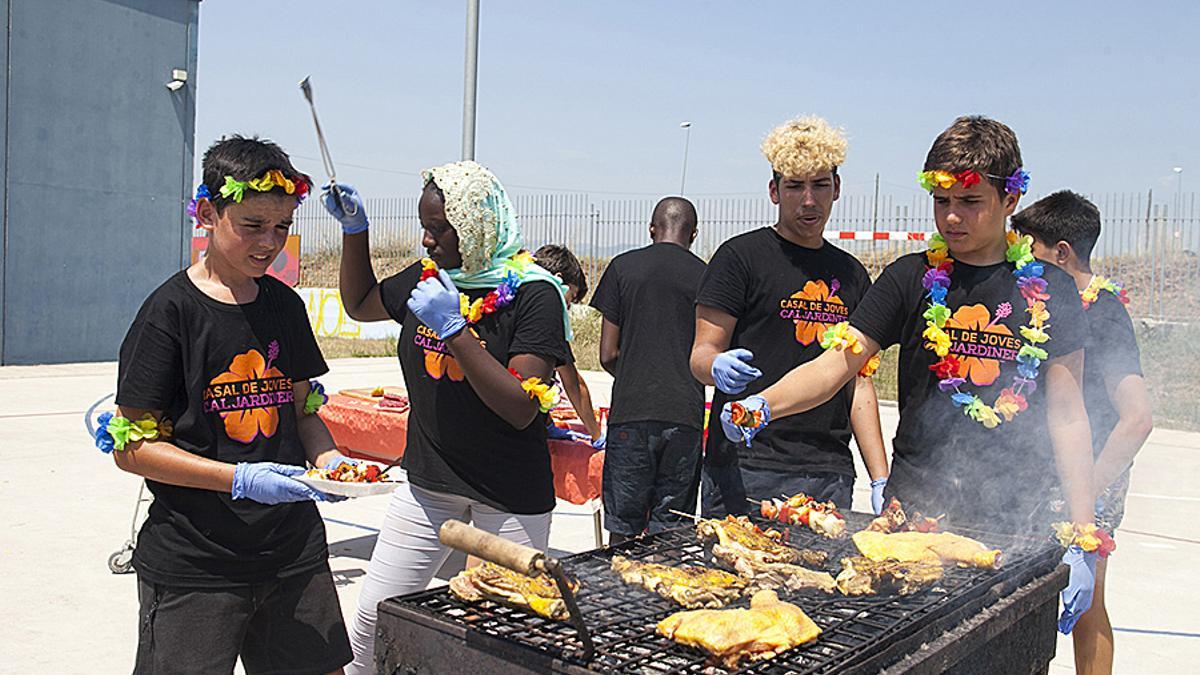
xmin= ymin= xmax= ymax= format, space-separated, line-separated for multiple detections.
xmin=0 ymin=0 xmax=199 ymax=364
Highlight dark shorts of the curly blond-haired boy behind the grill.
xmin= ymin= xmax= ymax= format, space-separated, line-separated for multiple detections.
xmin=700 ymin=464 xmax=854 ymax=518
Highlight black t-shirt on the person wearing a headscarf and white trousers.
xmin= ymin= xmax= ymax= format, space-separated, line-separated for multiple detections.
xmin=379 ymin=263 xmax=566 ymax=513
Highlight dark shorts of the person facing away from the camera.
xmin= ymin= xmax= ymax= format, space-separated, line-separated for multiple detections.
xmin=601 ymin=422 xmax=702 ymax=537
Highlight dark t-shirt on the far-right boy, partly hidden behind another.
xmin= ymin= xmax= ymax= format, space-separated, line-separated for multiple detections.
xmin=1084 ymin=291 xmax=1141 ymax=455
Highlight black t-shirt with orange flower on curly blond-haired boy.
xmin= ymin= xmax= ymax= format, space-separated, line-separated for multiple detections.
xmin=696 ymin=227 xmax=871 ymax=476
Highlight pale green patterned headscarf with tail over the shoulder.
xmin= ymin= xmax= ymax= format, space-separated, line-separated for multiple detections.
xmin=421 ymin=160 xmax=575 ymax=340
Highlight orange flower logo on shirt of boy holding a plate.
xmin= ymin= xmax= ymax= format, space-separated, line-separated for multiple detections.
xmin=204 ymin=340 xmax=294 ymax=443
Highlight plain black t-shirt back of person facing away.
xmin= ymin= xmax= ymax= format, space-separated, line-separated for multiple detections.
xmin=592 ymin=243 xmax=704 ymax=429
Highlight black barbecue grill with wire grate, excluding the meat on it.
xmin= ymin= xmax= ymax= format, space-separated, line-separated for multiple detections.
xmin=376 ymin=514 xmax=1067 ymax=675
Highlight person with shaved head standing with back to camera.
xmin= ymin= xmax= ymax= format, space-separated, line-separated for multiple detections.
xmin=592 ymin=197 xmax=704 ymax=544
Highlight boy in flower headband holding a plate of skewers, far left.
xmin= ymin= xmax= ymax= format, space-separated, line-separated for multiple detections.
xmin=103 ymin=136 xmax=350 ymax=673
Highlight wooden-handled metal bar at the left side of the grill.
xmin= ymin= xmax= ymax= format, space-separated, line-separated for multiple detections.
xmin=438 ymin=520 xmax=596 ymax=661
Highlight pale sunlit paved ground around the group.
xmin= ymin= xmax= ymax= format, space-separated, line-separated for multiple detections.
xmin=0 ymin=359 xmax=1200 ymax=674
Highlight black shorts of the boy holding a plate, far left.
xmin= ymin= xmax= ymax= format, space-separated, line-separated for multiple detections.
xmin=133 ymin=566 xmax=353 ymax=675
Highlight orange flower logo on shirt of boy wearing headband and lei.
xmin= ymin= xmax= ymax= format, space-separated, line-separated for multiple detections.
xmin=946 ymin=303 xmax=1021 ymax=387
